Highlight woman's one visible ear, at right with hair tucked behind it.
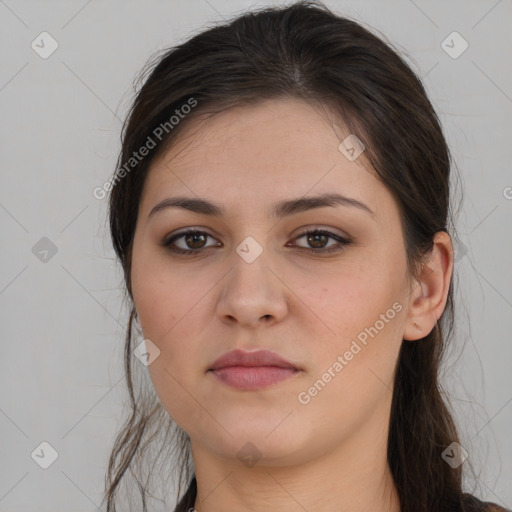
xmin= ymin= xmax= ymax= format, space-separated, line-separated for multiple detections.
xmin=403 ymin=231 xmax=453 ymax=341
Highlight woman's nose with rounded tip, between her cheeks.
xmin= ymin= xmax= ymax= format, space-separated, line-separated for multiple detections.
xmin=217 ymin=253 xmax=291 ymax=329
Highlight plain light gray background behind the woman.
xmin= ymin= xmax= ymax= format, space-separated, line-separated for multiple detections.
xmin=0 ymin=0 xmax=512 ymax=512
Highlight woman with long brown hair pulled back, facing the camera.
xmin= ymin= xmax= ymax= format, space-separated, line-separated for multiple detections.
xmin=106 ymin=2 xmax=503 ymax=512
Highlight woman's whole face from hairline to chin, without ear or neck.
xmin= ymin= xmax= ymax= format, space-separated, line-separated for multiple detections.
xmin=131 ymin=99 xmax=410 ymax=465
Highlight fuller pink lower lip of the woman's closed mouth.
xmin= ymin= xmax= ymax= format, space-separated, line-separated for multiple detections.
xmin=211 ymin=366 xmax=298 ymax=389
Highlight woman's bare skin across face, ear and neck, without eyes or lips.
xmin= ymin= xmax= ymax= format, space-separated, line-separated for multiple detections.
xmin=131 ymin=99 xmax=453 ymax=512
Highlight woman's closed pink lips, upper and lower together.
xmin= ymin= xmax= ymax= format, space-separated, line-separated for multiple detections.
xmin=207 ymin=349 xmax=300 ymax=390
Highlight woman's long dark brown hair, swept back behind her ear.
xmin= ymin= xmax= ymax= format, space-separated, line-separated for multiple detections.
xmin=105 ymin=1 xmax=472 ymax=512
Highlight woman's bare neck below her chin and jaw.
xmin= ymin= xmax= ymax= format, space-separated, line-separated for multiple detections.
xmin=192 ymin=422 xmax=400 ymax=512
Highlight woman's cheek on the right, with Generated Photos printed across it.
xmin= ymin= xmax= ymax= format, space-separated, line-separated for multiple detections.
xmin=296 ymin=262 xmax=404 ymax=404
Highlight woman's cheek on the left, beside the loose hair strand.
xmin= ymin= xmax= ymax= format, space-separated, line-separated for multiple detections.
xmin=133 ymin=260 xmax=210 ymax=430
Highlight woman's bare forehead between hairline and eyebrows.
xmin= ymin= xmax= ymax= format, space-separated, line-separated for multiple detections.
xmin=141 ymin=99 xmax=391 ymax=222
